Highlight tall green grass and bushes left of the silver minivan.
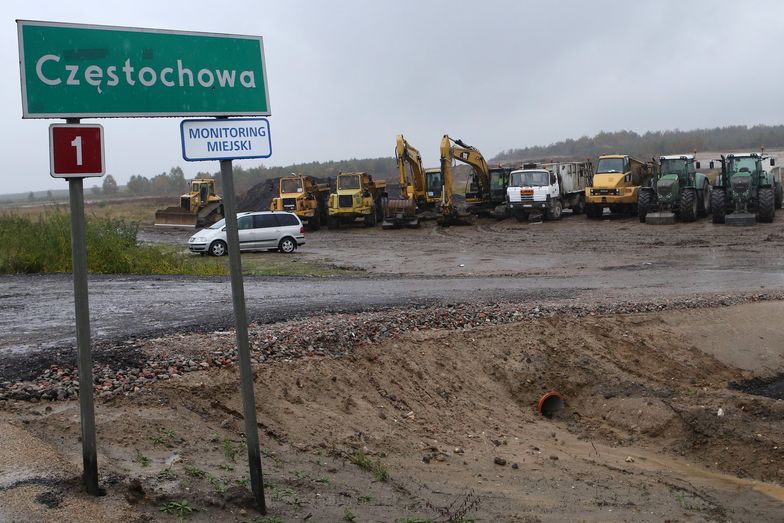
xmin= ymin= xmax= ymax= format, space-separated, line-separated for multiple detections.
xmin=0 ymin=209 xmax=227 ymax=276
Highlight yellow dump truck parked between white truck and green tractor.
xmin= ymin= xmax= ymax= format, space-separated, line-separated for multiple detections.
xmin=585 ymin=154 xmax=656 ymax=218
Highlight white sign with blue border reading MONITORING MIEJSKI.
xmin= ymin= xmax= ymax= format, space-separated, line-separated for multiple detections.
xmin=180 ymin=118 xmax=272 ymax=162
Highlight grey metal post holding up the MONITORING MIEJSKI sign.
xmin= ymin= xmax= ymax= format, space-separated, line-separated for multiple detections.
xmin=220 ymin=156 xmax=267 ymax=515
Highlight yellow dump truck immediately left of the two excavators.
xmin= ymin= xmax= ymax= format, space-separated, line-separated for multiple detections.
xmin=327 ymin=172 xmax=387 ymax=229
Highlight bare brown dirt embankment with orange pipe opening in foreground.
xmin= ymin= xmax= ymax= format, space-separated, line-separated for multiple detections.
xmin=0 ymin=302 xmax=784 ymax=522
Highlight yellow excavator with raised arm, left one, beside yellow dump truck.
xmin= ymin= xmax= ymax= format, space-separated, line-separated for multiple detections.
xmin=382 ymin=134 xmax=443 ymax=229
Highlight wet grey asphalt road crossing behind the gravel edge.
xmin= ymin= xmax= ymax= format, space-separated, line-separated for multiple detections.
xmin=0 ymin=262 xmax=784 ymax=353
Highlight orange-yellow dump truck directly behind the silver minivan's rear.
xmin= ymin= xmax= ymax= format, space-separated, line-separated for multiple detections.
xmin=270 ymin=174 xmax=329 ymax=231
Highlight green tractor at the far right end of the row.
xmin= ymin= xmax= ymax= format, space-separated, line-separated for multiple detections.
xmin=710 ymin=153 xmax=782 ymax=225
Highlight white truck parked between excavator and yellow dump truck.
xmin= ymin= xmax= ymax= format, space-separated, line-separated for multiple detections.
xmin=506 ymin=162 xmax=593 ymax=221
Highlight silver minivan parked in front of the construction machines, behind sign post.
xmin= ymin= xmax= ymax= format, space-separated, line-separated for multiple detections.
xmin=188 ymin=211 xmax=305 ymax=256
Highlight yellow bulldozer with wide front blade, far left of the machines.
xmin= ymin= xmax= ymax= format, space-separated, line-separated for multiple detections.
xmin=155 ymin=178 xmax=223 ymax=227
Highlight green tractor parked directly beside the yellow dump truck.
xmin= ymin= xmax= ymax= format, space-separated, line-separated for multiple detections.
xmin=637 ymin=154 xmax=711 ymax=225
